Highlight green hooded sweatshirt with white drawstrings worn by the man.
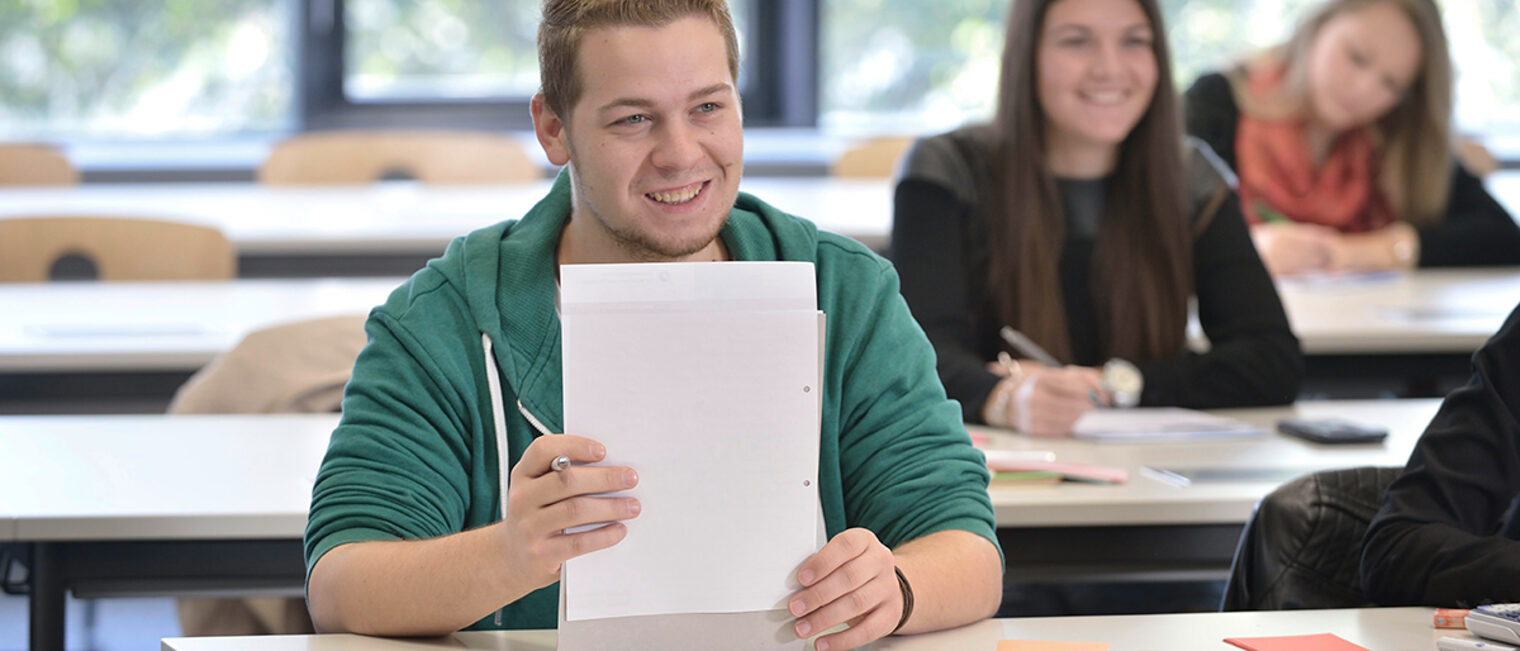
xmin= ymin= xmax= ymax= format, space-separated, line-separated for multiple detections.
xmin=306 ymin=173 xmax=997 ymax=628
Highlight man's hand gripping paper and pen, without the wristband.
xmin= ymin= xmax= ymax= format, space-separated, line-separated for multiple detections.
xmin=502 ymin=433 xmax=640 ymax=595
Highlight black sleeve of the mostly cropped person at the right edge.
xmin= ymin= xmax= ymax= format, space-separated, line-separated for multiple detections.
xmin=1362 ymin=309 xmax=1520 ymax=607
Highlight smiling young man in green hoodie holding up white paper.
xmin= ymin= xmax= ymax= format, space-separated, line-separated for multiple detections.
xmin=306 ymin=0 xmax=1002 ymax=651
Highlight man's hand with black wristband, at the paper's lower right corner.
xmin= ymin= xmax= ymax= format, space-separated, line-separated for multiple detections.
xmin=787 ymin=528 xmax=903 ymax=651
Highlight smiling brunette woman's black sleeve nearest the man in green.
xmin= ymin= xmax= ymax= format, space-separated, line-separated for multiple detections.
xmin=891 ymin=179 xmax=999 ymax=423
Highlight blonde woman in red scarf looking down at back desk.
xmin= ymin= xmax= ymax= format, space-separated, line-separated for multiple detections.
xmin=1186 ymin=0 xmax=1520 ymax=274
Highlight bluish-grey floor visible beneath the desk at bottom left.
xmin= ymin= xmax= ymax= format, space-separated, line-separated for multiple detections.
xmin=0 ymin=595 xmax=179 ymax=651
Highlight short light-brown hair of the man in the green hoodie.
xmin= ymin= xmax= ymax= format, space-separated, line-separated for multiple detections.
xmin=538 ymin=0 xmax=739 ymax=117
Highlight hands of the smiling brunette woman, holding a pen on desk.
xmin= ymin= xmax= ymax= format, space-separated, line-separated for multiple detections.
xmin=982 ymin=360 xmax=1108 ymax=437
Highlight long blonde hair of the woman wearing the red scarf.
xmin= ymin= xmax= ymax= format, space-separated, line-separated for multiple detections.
xmin=1227 ymin=0 xmax=1452 ymax=224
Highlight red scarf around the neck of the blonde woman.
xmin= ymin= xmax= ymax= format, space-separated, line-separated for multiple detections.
xmin=1236 ymin=68 xmax=1394 ymax=233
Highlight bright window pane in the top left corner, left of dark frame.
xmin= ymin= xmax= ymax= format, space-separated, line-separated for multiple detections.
xmin=0 ymin=0 xmax=296 ymax=140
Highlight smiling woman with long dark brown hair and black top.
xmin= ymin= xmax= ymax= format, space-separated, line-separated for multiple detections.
xmin=891 ymin=0 xmax=1303 ymax=435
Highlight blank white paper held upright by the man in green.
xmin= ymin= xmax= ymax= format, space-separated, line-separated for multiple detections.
xmin=561 ymin=263 xmax=819 ymax=621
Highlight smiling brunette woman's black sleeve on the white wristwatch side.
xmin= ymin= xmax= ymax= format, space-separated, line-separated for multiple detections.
xmin=1138 ymin=193 xmax=1304 ymax=409
